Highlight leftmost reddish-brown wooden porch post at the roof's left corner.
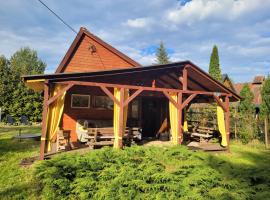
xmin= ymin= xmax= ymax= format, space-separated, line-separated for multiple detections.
xmin=40 ymin=80 xmax=49 ymax=160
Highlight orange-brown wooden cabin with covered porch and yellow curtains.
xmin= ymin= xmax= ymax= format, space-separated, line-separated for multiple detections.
xmin=23 ymin=28 xmax=240 ymax=159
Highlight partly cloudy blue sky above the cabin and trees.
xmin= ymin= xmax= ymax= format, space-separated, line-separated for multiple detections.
xmin=0 ymin=0 xmax=270 ymax=82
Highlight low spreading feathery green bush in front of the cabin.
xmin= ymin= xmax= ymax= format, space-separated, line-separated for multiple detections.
xmin=35 ymin=146 xmax=270 ymax=199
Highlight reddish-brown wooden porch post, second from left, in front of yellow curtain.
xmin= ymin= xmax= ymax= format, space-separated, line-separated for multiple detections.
xmin=116 ymin=88 xmax=125 ymax=149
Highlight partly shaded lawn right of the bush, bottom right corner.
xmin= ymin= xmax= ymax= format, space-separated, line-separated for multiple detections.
xmin=206 ymin=151 xmax=270 ymax=199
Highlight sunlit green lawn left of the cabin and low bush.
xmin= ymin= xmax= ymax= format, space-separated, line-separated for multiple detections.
xmin=0 ymin=126 xmax=40 ymax=199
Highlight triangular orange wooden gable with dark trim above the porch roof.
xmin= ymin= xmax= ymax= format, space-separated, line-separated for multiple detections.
xmin=55 ymin=28 xmax=141 ymax=73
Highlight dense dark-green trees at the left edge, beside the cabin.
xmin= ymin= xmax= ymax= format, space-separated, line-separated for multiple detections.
xmin=0 ymin=48 xmax=46 ymax=122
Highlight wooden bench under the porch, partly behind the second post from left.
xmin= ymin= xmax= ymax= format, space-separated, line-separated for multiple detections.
xmin=86 ymin=127 xmax=141 ymax=148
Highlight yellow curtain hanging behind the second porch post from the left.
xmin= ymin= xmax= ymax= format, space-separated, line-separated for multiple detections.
xmin=113 ymin=88 xmax=129 ymax=148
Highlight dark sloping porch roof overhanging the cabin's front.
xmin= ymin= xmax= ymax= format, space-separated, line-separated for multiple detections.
xmin=22 ymin=61 xmax=241 ymax=101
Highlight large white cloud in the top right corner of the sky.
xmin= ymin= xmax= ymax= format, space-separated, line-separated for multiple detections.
xmin=167 ymin=0 xmax=270 ymax=25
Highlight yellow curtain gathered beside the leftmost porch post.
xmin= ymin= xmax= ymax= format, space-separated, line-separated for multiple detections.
xmin=46 ymin=84 xmax=66 ymax=152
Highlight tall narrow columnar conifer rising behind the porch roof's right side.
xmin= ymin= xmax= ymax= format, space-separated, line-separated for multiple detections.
xmin=209 ymin=45 xmax=222 ymax=81
